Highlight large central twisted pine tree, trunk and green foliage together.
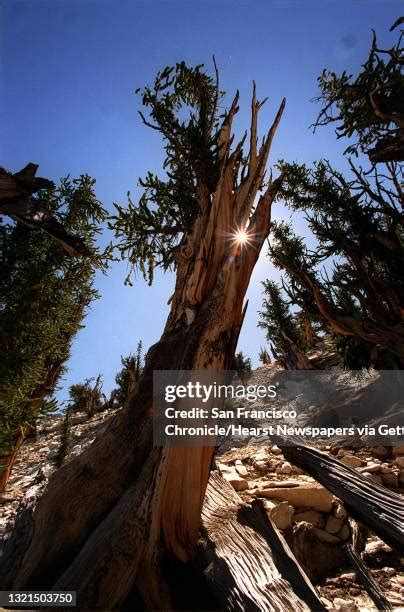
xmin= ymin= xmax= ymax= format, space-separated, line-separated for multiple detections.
xmin=3 ymin=63 xmax=285 ymax=609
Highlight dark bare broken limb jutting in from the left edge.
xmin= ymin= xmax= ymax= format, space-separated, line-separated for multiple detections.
xmin=0 ymin=163 xmax=90 ymax=257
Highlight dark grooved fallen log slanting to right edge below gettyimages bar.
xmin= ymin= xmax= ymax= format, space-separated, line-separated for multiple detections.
xmin=280 ymin=442 xmax=404 ymax=550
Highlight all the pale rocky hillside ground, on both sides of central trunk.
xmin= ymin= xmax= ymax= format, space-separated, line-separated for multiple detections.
xmin=0 ymin=368 xmax=404 ymax=611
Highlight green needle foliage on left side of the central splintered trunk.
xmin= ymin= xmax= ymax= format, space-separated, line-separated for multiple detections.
xmin=109 ymin=62 xmax=222 ymax=284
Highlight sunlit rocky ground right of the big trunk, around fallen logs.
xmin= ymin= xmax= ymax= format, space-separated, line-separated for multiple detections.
xmin=216 ymin=445 xmax=404 ymax=611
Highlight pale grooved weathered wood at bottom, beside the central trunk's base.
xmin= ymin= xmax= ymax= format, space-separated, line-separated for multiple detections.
xmin=202 ymin=472 xmax=324 ymax=612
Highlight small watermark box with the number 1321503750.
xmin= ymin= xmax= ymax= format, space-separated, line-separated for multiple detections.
xmin=0 ymin=591 xmax=76 ymax=609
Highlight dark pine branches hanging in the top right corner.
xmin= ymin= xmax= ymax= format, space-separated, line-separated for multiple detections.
xmin=314 ymin=17 xmax=404 ymax=163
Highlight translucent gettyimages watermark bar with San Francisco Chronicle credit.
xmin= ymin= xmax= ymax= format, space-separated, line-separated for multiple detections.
xmin=153 ymin=369 xmax=404 ymax=446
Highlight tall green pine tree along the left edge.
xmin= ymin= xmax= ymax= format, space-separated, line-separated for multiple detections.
xmin=0 ymin=175 xmax=106 ymax=490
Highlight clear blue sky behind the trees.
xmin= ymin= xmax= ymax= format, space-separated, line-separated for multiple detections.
xmin=0 ymin=0 xmax=402 ymax=399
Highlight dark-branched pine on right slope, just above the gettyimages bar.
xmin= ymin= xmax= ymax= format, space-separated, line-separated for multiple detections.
xmin=270 ymin=155 xmax=404 ymax=369
